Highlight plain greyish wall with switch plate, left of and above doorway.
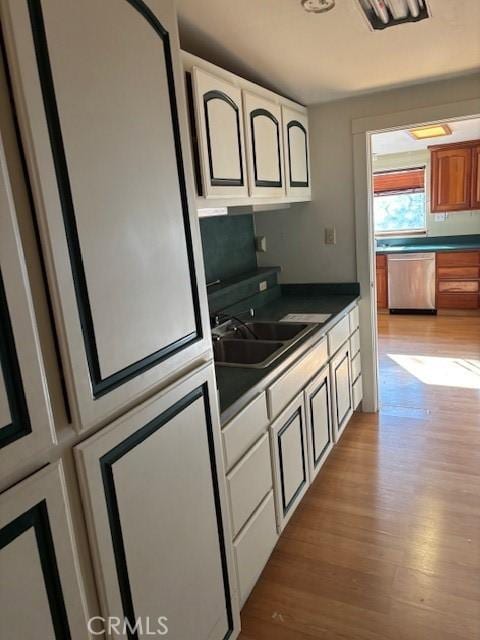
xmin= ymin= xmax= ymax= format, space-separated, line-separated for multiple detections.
xmin=255 ymin=74 xmax=480 ymax=282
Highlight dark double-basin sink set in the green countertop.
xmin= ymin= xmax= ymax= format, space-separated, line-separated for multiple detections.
xmin=213 ymin=322 xmax=318 ymax=369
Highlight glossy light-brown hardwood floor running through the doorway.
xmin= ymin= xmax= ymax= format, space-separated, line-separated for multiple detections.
xmin=240 ymin=315 xmax=480 ymax=640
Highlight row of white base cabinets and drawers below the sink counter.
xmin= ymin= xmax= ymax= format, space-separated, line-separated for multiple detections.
xmin=222 ymin=304 xmax=363 ymax=607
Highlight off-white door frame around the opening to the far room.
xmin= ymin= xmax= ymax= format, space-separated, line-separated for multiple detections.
xmin=351 ymin=98 xmax=480 ymax=412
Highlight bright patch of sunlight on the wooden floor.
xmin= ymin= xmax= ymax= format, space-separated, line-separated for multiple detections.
xmin=387 ymin=353 xmax=480 ymax=389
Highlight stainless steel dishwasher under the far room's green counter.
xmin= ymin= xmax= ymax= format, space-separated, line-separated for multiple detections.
xmin=387 ymin=253 xmax=435 ymax=313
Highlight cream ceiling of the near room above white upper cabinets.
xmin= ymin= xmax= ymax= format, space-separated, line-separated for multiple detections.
xmin=177 ymin=0 xmax=480 ymax=104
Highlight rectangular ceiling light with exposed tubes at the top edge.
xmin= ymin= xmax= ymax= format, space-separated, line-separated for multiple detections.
xmin=358 ymin=0 xmax=430 ymax=30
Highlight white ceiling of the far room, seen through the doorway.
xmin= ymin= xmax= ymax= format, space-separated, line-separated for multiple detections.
xmin=372 ymin=118 xmax=480 ymax=156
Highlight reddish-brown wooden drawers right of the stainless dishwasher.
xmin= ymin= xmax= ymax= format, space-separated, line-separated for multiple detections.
xmin=437 ymin=251 xmax=480 ymax=309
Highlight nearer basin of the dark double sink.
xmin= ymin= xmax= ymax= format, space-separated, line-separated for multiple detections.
xmin=213 ymin=338 xmax=285 ymax=368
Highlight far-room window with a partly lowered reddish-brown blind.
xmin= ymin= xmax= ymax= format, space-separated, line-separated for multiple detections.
xmin=373 ymin=167 xmax=426 ymax=235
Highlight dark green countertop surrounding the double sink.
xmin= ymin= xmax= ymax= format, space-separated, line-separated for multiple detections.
xmin=215 ymin=295 xmax=358 ymax=425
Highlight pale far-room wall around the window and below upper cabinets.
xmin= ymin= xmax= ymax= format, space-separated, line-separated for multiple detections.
xmin=372 ymin=149 xmax=480 ymax=237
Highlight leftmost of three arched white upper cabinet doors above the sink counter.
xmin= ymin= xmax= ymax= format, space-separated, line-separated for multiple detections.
xmin=192 ymin=67 xmax=248 ymax=198
